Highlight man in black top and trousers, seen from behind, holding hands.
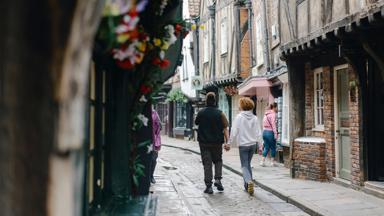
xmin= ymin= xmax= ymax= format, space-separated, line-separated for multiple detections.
xmin=195 ymin=92 xmax=229 ymax=194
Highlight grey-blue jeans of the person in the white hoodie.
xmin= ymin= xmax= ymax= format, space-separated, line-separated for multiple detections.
xmin=239 ymin=144 xmax=256 ymax=187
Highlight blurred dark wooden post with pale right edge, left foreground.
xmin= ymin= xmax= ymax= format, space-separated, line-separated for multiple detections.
xmin=0 ymin=0 xmax=103 ymax=215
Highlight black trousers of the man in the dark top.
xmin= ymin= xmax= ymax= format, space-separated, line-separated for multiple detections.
xmin=200 ymin=144 xmax=223 ymax=186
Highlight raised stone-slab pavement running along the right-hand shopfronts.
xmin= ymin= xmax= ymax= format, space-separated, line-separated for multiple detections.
xmin=162 ymin=136 xmax=384 ymax=216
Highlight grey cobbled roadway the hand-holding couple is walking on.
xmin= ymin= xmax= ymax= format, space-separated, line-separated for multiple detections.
xmin=151 ymin=147 xmax=307 ymax=216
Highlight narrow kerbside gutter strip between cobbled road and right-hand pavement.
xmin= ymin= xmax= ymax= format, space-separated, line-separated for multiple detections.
xmin=162 ymin=144 xmax=324 ymax=216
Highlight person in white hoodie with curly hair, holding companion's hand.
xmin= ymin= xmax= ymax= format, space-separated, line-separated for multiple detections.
xmin=229 ymin=97 xmax=262 ymax=195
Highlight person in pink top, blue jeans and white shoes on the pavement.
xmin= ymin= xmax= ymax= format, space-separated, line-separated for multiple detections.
xmin=260 ymin=103 xmax=278 ymax=166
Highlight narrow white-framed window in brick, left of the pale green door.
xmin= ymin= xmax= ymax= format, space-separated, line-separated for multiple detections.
xmin=314 ymin=68 xmax=324 ymax=129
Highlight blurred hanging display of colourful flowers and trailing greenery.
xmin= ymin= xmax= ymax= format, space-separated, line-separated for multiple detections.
xmin=97 ymin=0 xmax=191 ymax=188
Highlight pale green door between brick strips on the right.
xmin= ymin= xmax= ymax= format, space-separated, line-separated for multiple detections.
xmin=334 ymin=65 xmax=351 ymax=180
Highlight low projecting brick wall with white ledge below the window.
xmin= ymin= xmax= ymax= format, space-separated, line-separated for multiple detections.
xmin=293 ymin=141 xmax=327 ymax=181
